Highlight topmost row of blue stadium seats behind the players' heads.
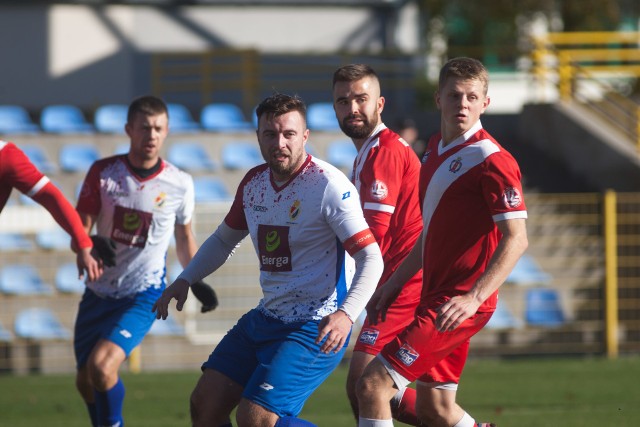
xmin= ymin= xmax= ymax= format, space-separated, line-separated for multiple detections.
xmin=0 ymin=102 xmax=340 ymax=135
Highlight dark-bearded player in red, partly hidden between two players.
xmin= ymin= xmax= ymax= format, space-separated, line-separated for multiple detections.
xmin=333 ymin=64 xmax=422 ymax=425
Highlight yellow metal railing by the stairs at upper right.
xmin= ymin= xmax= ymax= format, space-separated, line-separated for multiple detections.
xmin=532 ymin=32 xmax=640 ymax=150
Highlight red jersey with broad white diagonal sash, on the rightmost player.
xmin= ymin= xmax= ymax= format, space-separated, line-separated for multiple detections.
xmin=420 ymin=122 xmax=527 ymax=312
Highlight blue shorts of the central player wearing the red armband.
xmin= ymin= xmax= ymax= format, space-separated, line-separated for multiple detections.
xmin=202 ymin=309 xmax=349 ymax=417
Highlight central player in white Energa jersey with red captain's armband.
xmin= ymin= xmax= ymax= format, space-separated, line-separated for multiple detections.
xmin=154 ymin=94 xmax=383 ymax=427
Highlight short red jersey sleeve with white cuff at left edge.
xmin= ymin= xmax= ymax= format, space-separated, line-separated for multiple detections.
xmin=0 ymin=141 xmax=49 ymax=211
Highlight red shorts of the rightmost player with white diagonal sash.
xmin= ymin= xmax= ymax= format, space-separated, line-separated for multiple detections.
xmin=380 ymin=308 xmax=493 ymax=384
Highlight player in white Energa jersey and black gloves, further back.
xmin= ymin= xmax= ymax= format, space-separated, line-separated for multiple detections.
xmin=74 ymin=96 xmax=218 ymax=426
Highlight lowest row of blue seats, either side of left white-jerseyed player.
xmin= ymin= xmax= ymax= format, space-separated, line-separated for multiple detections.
xmin=0 ymin=307 xmax=185 ymax=342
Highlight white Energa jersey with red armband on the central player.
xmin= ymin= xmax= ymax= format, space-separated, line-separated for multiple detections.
xmin=224 ymin=156 xmax=372 ymax=322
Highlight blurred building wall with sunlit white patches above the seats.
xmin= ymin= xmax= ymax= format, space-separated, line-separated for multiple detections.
xmin=0 ymin=3 xmax=418 ymax=111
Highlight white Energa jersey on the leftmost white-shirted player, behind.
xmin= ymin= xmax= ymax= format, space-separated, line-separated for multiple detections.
xmin=77 ymin=155 xmax=195 ymax=298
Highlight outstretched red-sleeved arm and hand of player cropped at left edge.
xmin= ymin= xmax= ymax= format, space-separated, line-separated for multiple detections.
xmin=0 ymin=141 xmax=102 ymax=281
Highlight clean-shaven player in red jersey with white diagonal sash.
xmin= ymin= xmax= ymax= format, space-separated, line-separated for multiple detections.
xmin=358 ymin=58 xmax=528 ymax=427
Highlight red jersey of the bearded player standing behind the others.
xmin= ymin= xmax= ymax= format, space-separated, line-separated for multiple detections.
xmin=351 ymin=124 xmax=422 ymax=284
